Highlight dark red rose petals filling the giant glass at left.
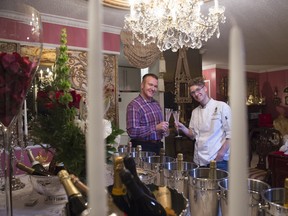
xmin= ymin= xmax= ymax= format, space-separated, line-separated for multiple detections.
xmin=0 ymin=52 xmax=36 ymax=127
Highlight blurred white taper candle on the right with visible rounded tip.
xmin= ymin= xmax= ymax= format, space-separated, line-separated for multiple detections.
xmin=228 ymin=26 xmax=248 ymax=216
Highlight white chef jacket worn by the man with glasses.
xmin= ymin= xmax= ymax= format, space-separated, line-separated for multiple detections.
xmin=189 ymin=98 xmax=231 ymax=166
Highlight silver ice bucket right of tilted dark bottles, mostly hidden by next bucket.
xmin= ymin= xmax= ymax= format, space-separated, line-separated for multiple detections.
xmin=142 ymin=156 xmax=175 ymax=185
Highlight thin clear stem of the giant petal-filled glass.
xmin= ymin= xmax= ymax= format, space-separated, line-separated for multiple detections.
xmin=3 ymin=127 xmax=13 ymax=216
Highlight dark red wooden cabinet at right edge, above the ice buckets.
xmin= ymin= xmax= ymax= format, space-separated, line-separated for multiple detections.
xmin=268 ymin=152 xmax=288 ymax=187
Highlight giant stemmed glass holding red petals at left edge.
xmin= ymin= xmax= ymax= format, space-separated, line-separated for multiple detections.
xmin=0 ymin=0 xmax=43 ymax=216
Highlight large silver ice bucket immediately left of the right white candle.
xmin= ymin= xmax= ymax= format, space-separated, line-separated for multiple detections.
xmin=189 ymin=168 xmax=228 ymax=216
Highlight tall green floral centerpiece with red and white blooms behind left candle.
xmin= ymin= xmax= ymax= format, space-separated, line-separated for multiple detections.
xmin=32 ymin=29 xmax=124 ymax=177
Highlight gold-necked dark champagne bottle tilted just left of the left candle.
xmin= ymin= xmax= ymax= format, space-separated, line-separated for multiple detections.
xmin=58 ymin=170 xmax=89 ymax=216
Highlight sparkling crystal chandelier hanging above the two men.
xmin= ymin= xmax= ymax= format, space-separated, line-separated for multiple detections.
xmin=124 ymin=0 xmax=226 ymax=52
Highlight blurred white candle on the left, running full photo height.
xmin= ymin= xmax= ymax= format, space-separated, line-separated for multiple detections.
xmin=86 ymin=0 xmax=107 ymax=215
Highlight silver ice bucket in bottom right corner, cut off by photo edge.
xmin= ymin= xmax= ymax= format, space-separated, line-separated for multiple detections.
xmin=261 ymin=188 xmax=288 ymax=216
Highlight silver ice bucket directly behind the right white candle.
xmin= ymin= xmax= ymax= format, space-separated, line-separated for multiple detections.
xmin=218 ymin=179 xmax=270 ymax=216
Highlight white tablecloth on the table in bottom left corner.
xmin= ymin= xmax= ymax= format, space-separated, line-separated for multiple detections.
xmin=0 ymin=175 xmax=65 ymax=216
